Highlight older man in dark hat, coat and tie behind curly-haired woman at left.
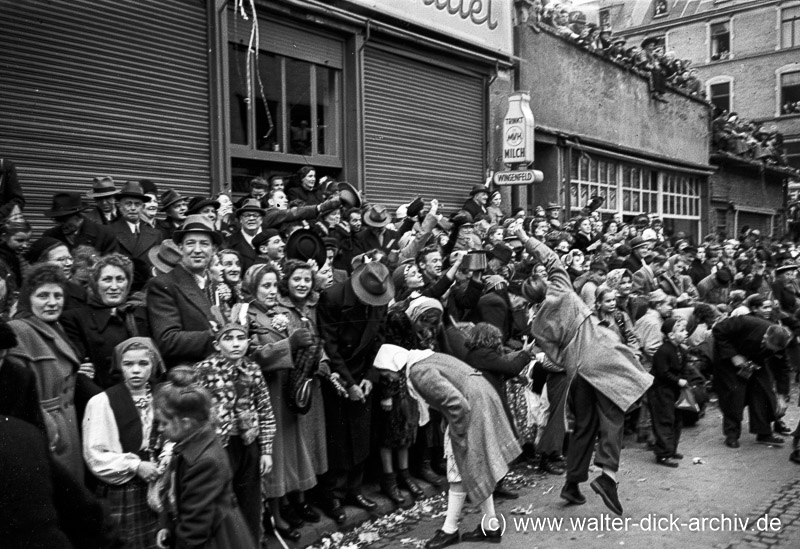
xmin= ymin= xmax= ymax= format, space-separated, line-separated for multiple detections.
xmin=108 ymin=181 xmax=164 ymax=293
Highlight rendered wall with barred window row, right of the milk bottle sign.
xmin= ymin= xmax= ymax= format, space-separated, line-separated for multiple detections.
xmin=516 ymin=25 xmax=714 ymax=236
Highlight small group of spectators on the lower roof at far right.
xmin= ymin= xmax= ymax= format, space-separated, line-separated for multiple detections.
xmin=711 ymin=111 xmax=787 ymax=166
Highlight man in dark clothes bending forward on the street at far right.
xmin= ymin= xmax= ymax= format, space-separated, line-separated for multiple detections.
xmin=712 ymin=315 xmax=793 ymax=448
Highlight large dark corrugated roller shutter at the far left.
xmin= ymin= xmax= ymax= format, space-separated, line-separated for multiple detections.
xmin=0 ymin=0 xmax=211 ymax=232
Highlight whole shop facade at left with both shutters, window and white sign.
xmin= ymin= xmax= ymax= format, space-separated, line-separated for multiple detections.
xmin=0 ymin=0 xmax=513 ymax=228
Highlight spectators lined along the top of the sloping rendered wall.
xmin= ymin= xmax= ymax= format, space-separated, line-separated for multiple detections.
xmin=517 ymin=0 xmax=705 ymax=101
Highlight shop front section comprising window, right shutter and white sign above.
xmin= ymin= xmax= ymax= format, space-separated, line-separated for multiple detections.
xmin=220 ymin=1 xmax=512 ymax=211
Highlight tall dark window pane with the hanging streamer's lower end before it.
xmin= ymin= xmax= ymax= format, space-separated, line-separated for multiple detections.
xmin=254 ymin=52 xmax=286 ymax=152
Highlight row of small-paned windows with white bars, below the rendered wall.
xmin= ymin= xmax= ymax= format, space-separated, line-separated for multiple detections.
xmin=570 ymin=152 xmax=700 ymax=219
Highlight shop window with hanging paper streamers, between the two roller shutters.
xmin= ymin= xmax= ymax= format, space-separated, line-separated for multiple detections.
xmin=228 ymin=14 xmax=344 ymax=166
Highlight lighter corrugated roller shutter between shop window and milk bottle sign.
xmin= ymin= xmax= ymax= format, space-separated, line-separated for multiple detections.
xmin=364 ymin=46 xmax=486 ymax=212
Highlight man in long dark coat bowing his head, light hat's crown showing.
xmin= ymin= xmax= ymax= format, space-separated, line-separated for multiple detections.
xmin=318 ymin=262 xmax=394 ymax=524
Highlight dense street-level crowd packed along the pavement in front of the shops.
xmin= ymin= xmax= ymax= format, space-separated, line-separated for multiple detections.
xmin=0 ymin=166 xmax=800 ymax=549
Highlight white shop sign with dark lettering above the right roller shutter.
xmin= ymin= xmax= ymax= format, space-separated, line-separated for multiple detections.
xmin=348 ymin=0 xmax=514 ymax=57
